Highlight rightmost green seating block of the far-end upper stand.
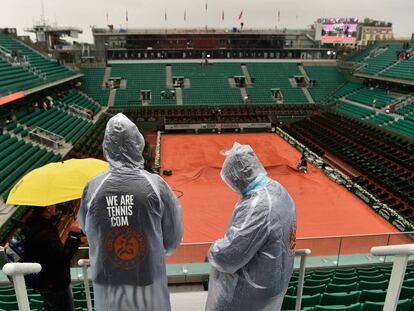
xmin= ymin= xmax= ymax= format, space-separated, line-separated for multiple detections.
xmin=304 ymin=66 xmax=346 ymax=102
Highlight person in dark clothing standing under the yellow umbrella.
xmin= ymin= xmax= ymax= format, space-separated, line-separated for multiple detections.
xmin=22 ymin=205 xmax=80 ymax=311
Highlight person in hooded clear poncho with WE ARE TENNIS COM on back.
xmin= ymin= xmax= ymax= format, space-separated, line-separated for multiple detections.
xmin=78 ymin=114 xmax=183 ymax=311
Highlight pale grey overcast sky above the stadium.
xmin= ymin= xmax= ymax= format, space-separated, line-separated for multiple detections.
xmin=0 ymin=0 xmax=414 ymax=42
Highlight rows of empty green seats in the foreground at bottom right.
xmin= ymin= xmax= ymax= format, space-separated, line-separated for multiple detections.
xmin=281 ymin=265 xmax=414 ymax=311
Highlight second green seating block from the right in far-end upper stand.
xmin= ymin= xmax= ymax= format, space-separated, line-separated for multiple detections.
xmin=247 ymin=63 xmax=309 ymax=104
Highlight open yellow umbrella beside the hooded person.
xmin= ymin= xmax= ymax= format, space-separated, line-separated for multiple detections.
xmin=7 ymin=159 xmax=108 ymax=206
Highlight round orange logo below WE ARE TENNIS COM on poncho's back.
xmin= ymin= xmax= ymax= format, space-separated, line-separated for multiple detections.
xmin=106 ymin=227 xmax=147 ymax=269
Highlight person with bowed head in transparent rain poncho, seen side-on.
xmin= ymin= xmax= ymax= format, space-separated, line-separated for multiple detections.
xmin=206 ymin=143 xmax=296 ymax=311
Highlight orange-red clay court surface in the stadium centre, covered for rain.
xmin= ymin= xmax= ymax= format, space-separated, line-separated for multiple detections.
xmin=161 ymin=133 xmax=397 ymax=243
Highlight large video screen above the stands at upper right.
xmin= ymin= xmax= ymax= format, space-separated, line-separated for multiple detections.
xmin=318 ymin=18 xmax=358 ymax=43
